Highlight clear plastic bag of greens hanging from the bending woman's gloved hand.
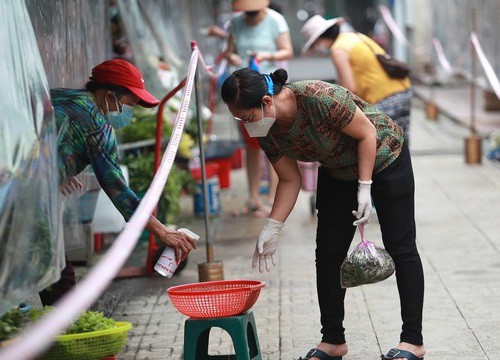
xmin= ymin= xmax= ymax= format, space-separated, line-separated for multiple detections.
xmin=340 ymin=225 xmax=394 ymax=289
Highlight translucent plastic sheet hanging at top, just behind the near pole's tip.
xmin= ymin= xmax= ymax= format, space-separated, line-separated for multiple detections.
xmin=117 ymin=0 xmax=220 ymax=99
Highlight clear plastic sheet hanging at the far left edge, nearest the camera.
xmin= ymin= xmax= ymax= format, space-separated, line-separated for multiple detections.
xmin=0 ymin=0 xmax=60 ymax=314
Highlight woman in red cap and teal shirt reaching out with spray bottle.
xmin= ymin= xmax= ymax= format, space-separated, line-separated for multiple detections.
xmin=40 ymin=59 xmax=196 ymax=305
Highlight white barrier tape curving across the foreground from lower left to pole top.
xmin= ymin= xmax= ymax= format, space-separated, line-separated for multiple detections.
xmin=0 ymin=47 xmax=199 ymax=360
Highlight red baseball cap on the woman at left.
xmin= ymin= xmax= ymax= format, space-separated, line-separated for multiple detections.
xmin=90 ymin=59 xmax=160 ymax=108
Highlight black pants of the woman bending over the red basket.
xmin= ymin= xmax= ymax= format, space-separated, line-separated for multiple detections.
xmin=316 ymin=144 xmax=424 ymax=345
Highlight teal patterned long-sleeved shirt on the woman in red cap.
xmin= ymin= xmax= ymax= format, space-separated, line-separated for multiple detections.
xmin=50 ymin=89 xmax=139 ymax=220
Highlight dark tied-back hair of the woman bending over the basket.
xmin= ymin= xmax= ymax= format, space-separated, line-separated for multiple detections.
xmin=221 ymin=68 xmax=288 ymax=109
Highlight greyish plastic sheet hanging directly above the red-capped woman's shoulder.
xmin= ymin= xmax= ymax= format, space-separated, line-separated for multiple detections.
xmin=25 ymin=0 xmax=111 ymax=89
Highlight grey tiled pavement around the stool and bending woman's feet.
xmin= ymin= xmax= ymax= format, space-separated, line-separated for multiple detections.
xmin=88 ymin=95 xmax=500 ymax=360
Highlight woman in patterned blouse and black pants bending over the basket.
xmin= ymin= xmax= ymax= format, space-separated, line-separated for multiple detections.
xmin=221 ymin=69 xmax=425 ymax=360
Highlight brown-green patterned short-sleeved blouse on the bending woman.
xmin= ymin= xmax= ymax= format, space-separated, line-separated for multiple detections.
xmin=259 ymin=80 xmax=403 ymax=181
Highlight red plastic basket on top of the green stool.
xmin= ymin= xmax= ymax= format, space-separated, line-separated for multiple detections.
xmin=168 ymin=280 xmax=265 ymax=318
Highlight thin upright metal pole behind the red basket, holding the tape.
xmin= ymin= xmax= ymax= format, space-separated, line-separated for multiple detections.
xmin=191 ymin=41 xmax=214 ymax=262
